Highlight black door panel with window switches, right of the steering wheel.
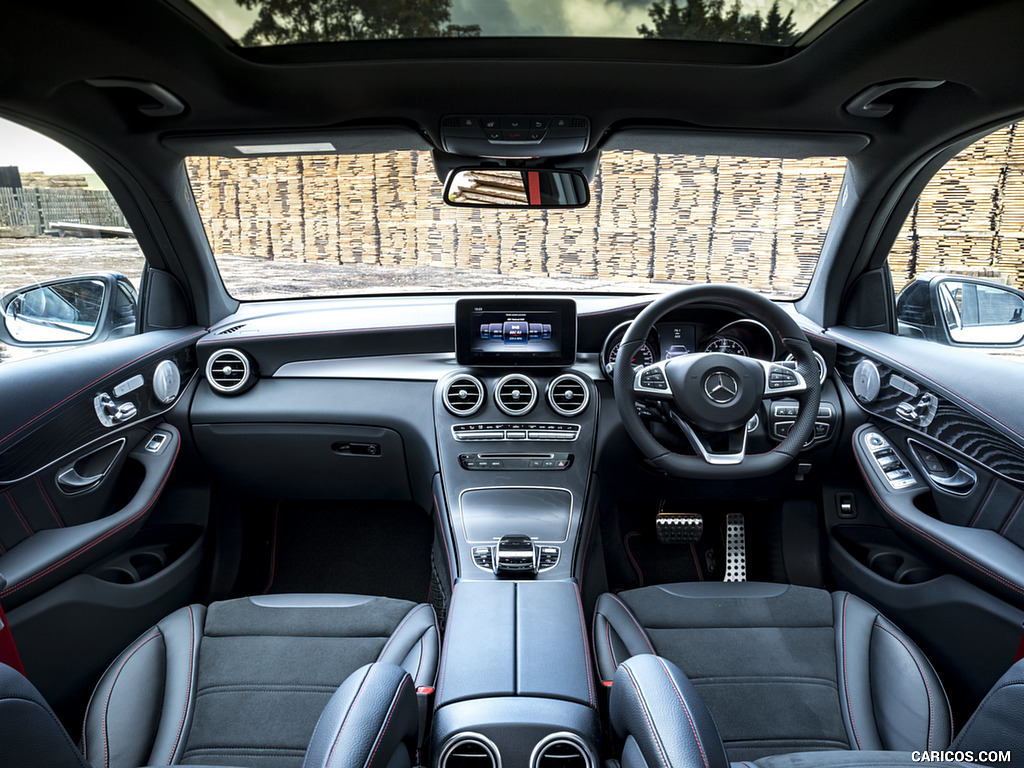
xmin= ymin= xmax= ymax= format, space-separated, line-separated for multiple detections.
xmin=825 ymin=329 xmax=1024 ymax=719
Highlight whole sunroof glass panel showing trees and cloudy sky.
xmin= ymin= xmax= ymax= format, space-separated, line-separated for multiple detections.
xmin=193 ymin=0 xmax=855 ymax=46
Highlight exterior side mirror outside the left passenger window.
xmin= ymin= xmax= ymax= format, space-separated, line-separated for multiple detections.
xmin=0 ymin=272 xmax=138 ymax=347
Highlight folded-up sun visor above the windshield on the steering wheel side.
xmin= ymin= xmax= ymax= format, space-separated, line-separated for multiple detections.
xmin=601 ymin=126 xmax=870 ymax=160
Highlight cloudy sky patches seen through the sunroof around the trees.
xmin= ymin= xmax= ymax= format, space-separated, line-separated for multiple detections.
xmin=193 ymin=0 xmax=837 ymax=38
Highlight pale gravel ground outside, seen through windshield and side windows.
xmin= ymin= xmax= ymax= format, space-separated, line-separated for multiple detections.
xmin=0 ymin=238 xmax=1024 ymax=361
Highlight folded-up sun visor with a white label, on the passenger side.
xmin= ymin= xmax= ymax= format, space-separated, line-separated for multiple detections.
xmin=163 ymin=126 xmax=433 ymax=158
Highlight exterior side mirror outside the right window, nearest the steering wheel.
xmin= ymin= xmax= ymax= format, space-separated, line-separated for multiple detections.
xmin=896 ymin=275 xmax=1024 ymax=346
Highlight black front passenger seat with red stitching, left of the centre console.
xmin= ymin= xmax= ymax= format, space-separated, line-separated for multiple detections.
xmin=0 ymin=595 xmax=439 ymax=768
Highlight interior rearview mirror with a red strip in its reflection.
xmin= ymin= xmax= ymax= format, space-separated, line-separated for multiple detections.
xmin=444 ymin=166 xmax=590 ymax=208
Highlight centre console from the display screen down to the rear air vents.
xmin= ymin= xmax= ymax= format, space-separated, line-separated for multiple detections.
xmin=431 ymin=298 xmax=600 ymax=768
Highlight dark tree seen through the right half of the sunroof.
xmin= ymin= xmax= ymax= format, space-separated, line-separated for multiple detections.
xmin=637 ymin=0 xmax=797 ymax=45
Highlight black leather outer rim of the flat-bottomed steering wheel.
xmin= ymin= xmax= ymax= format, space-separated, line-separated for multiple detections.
xmin=612 ymin=284 xmax=821 ymax=480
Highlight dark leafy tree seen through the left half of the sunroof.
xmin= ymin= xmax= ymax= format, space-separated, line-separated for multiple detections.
xmin=236 ymin=0 xmax=480 ymax=45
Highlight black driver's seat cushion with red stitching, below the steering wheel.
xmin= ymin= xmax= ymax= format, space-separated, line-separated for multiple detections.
xmin=594 ymin=582 xmax=952 ymax=762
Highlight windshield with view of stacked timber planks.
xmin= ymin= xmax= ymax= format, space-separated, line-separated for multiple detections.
xmin=186 ymin=152 xmax=846 ymax=300
